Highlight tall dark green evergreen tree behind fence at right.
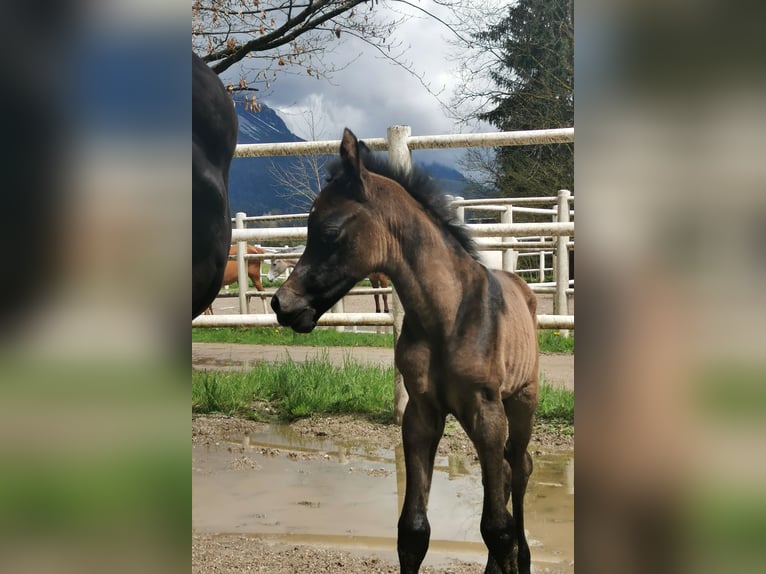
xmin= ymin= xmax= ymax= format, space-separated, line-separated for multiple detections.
xmin=476 ymin=0 xmax=574 ymax=197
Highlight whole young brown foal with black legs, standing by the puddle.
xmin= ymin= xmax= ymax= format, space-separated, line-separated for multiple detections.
xmin=271 ymin=130 xmax=539 ymax=574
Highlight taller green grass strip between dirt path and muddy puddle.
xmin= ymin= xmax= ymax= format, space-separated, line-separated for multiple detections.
xmin=192 ymin=356 xmax=574 ymax=432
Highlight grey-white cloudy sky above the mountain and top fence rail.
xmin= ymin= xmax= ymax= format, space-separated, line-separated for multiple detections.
xmin=224 ymin=0 xmax=496 ymax=161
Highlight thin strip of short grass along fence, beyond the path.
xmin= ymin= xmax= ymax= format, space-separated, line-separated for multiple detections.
xmin=192 ymin=327 xmax=574 ymax=353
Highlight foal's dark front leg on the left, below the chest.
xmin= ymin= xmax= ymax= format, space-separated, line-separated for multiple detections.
xmin=397 ymin=395 xmax=445 ymax=574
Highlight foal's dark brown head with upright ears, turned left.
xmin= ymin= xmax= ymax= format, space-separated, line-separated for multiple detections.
xmin=271 ymin=129 xmax=390 ymax=332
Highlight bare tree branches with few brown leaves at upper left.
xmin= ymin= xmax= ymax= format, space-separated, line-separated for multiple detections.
xmin=192 ymin=0 xmax=464 ymax=106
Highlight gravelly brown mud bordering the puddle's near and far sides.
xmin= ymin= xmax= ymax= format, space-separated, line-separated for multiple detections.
xmin=192 ymin=415 xmax=574 ymax=574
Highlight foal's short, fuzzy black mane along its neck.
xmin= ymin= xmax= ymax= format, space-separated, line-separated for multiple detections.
xmin=327 ymin=145 xmax=480 ymax=261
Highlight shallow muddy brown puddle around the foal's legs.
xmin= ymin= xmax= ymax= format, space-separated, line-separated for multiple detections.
xmin=192 ymin=425 xmax=574 ymax=572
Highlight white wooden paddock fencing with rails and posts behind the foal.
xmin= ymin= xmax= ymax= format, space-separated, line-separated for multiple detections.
xmin=192 ymin=126 xmax=575 ymax=421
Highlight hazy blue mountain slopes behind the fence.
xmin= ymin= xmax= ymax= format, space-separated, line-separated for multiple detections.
xmin=229 ymin=105 xmax=468 ymax=216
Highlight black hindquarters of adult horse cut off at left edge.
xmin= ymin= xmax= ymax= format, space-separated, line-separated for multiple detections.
xmin=192 ymin=53 xmax=238 ymax=319
